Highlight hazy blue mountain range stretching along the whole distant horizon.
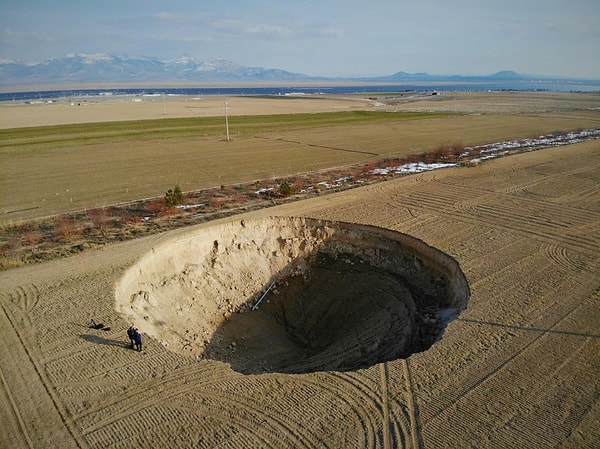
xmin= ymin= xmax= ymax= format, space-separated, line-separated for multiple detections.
xmin=0 ymin=53 xmax=592 ymax=88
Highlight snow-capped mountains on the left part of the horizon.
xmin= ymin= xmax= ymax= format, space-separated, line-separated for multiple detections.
xmin=0 ymin=53 xmax=308 ymax=86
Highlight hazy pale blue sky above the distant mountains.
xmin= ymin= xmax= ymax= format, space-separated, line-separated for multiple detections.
xmin=0 ymin=0 xmax=600 ymax=79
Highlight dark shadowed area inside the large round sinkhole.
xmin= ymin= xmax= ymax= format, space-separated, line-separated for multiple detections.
xmin=203 ymin=241 xmax=469 ymax=374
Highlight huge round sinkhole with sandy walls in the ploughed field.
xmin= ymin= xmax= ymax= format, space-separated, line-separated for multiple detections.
xmin=116 ymin=217 xmax=469 ymax=374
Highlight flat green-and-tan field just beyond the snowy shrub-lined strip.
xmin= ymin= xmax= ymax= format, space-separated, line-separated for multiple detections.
xmin=0 ymin=111 xmax=598 ymax=224
